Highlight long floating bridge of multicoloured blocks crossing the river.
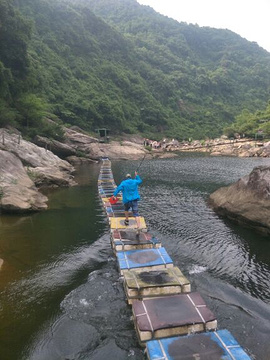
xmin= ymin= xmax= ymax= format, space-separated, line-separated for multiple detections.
xmin=98 ymin=158 xmax=251 ymax=360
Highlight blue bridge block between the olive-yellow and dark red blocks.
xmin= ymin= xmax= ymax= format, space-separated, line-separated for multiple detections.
xmin=116 ymin=247 xmax=173 ymax=271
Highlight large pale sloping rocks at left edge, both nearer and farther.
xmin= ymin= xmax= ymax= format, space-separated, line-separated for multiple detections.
xmin=0 ymin=129 xmax=76 ymax=213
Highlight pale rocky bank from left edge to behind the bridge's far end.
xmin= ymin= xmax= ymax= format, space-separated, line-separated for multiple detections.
xmin=0 ymin=128 xmax=151 ymax=213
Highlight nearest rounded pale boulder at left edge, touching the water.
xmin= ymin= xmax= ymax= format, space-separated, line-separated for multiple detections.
xmin=0 ymin=150 xmax=48 ymax=212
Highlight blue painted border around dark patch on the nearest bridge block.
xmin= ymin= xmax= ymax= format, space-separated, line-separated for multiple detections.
xmin=146 ymin=330 xmax=251 ymax=360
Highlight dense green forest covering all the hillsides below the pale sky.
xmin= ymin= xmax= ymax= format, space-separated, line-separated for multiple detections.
xmin=0 ymin=0 xmax=270 ymax=139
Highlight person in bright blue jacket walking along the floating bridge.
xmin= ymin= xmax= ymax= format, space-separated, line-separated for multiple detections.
xmin=113 ymin=171 xmax=142 ymax=230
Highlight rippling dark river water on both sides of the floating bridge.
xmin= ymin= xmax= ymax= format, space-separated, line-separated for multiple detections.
xmin=0 ymin=154 xmax=270 ymax=360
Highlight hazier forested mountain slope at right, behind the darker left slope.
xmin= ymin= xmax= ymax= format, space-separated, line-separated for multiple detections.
xmin=73 ymin=0 xmax=270 ymax=136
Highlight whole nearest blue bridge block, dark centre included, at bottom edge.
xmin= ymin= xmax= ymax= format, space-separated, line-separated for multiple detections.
xmin=146 ymin=330 xmax=251 ymax=360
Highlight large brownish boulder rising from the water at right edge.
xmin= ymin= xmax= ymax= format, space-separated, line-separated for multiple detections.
xmin=209 ymin=166 xmax=270 ymax=235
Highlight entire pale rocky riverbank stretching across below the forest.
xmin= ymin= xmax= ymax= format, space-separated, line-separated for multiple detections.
xmin=0 ymin=125 xmax=270 ymax=213
